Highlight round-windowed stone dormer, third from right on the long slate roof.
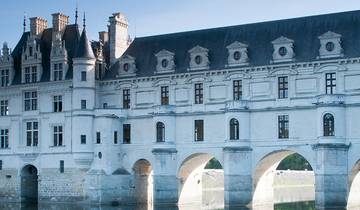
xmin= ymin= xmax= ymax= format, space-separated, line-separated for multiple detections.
xmin=226 ymin=41 xmax=249 ymax=67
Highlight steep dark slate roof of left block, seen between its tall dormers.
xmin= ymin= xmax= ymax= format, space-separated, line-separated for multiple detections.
xmin=11 ymin=24 xmax=80 ymax=85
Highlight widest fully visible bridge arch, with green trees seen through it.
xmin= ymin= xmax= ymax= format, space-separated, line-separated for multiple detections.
xmin=253 ymin=149 xmax=315 ymax=207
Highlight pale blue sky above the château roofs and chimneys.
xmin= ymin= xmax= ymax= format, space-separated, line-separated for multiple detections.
xmin=0 ymin=0 xmax=360 ymax=48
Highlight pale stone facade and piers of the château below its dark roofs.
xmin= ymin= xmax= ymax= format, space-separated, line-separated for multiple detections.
xmin=0 ymin=9 xmax=360 ymax=207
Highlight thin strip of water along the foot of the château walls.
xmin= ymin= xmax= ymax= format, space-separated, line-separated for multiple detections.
xmin=0 ymin=202 xmax=315 ymax=210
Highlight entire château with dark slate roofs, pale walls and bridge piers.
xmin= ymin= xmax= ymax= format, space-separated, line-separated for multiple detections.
xmin=0 ymin=11 xmax=360 ymax=207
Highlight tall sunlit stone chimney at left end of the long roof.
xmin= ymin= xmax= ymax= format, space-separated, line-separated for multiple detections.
xmin=109 ymin=13 xmax=129 ymax=64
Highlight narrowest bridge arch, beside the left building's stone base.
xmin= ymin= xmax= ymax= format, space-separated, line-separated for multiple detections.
xmin=132 ymin=159 xmax=153 ymax=204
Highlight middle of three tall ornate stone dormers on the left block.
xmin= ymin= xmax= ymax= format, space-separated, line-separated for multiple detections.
xmin=21 ymin=35 xmax=42 ymax=83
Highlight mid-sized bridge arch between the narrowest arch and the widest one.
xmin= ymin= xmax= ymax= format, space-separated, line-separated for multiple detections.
xmin=177 ymin=153 xmax=224 ymax=208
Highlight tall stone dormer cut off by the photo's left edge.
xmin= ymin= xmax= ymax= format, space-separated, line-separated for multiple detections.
xmin=0 ymin=42 xmax=14 ymax=87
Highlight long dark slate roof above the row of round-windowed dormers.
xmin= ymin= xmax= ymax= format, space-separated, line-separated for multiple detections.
xmin=105 ymin=11 xmax=360 ymax=79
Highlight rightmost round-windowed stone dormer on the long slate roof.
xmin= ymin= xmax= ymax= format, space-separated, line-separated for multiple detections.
xmin=318 ymin=31 xmax=344 ymax=58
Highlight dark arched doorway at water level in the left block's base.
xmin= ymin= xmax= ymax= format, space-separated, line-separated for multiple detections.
xmin=21 ymin=165 xmax=38 ymax=203
